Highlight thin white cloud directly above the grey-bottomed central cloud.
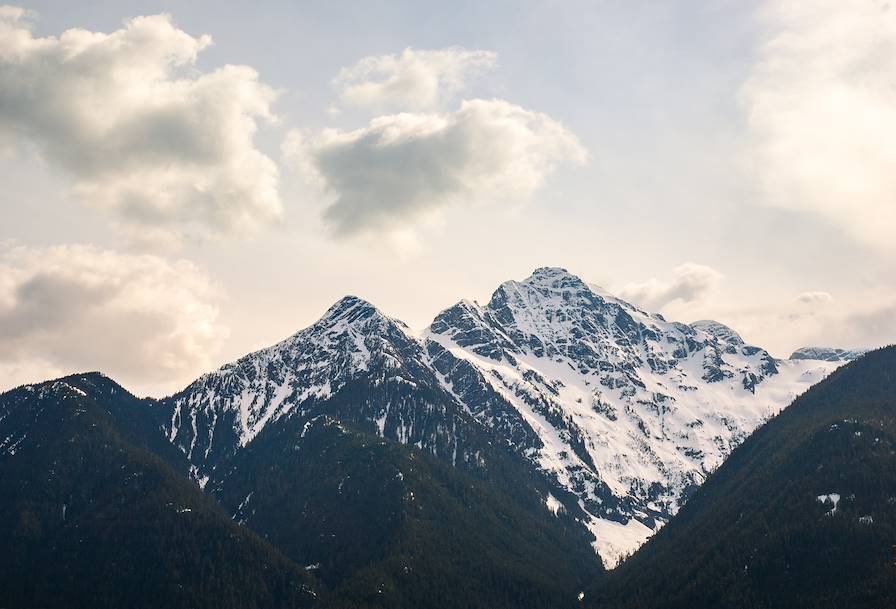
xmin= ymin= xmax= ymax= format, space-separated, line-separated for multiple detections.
xmin=334 ymin=47 xmax=497 ymax=112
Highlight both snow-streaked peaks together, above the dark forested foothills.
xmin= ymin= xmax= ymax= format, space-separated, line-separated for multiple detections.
xmin=161 ymin=268 xmax=856 ymax=566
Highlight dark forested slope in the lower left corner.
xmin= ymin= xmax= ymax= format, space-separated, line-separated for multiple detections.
xmin=0 ymin=374 xmax=314 ymax=609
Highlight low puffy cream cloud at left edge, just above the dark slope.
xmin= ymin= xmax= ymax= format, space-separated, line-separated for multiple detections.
xmin=0 ymin=245 xmax=227 ymax=390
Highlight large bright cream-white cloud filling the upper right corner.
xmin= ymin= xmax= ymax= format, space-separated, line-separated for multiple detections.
xmin=743 ymin=0 xmax=896 ymax=249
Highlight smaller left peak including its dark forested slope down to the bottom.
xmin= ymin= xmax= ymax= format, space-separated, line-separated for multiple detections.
xmin=158 ymin=297 xmax=602 ymax=607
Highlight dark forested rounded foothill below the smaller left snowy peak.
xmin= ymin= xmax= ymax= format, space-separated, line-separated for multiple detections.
xmin=210 ymin=404 xmax=602 ymax=609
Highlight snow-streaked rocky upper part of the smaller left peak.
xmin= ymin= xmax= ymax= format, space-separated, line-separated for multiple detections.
xmin=163 ymin=296 xmax=520 ymax=486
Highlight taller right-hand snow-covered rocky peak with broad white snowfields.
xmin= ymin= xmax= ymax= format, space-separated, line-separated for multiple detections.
xmin=423 ymin=268 xmax=841 ymax=566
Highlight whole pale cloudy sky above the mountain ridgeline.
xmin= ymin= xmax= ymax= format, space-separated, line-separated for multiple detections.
xmin=0 ymin=0 xmax=896 ymax=396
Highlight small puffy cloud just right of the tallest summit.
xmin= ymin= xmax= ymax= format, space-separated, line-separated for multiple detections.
xmin=618 ymin=262 xmax=724 ymax=311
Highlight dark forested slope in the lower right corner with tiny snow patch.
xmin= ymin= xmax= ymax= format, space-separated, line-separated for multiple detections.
xmin=586 ymin=347 xmax=896 ymax=609
